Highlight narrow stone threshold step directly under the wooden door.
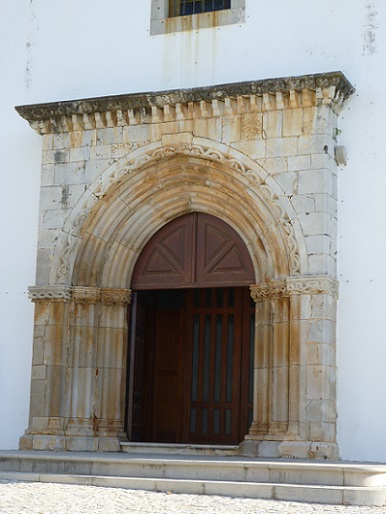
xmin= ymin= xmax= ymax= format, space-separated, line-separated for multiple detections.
xmin=121 ymin=442 xmax=239 ymax=457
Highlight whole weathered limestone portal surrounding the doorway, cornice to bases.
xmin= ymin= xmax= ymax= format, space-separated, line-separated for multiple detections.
xmin=17 ymin=73 xmax=353 ymax=458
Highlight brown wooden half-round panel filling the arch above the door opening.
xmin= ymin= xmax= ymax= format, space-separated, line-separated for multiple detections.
xmin=132 ymin=212 xmax=254 ymax=290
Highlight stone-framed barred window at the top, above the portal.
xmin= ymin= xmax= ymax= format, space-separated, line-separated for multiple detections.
xmin=150 ymin=0 xmax=246 ymax=36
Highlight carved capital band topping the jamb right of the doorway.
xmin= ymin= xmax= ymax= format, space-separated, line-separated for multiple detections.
xmin=250 ymin=275 xmax=339 ymax=302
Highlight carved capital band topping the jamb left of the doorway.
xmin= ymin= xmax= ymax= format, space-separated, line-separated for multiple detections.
xmin=28 ymin=285 xmax=132 ymax=305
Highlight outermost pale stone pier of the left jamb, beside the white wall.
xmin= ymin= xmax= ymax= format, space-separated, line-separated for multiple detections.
xmin=20 ymin=286 xmax=71 ymax=450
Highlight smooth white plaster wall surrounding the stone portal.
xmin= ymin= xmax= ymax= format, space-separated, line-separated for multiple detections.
xmin=0 ymin=0 xmax=386 ymax=461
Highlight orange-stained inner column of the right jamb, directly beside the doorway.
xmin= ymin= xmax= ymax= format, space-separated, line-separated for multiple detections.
xmin=242 ymin=281 xmax=289 ymax=457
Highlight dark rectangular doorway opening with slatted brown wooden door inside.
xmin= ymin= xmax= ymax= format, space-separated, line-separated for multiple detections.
xmin=127 ymin=287 xmax=254 ymax=444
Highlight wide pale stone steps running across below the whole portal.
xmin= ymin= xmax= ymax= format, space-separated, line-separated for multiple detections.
xmin=0 ymin=451 xmax=386 ymax=506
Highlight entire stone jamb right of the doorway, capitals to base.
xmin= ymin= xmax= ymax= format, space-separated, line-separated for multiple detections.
xmin=241 ymin=276 xmax=339 ymax=459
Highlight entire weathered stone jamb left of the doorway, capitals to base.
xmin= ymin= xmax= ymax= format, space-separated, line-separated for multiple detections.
xmin=20 ymin=285 xmax=131 ymax=451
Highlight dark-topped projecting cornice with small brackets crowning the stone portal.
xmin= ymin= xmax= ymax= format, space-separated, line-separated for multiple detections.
xmin=16 ymin=72 xmax=354 ymax=134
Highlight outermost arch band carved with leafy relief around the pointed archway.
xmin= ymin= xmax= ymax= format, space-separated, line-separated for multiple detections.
xmin=52 ymin=142 xmax=301 ymax=284
